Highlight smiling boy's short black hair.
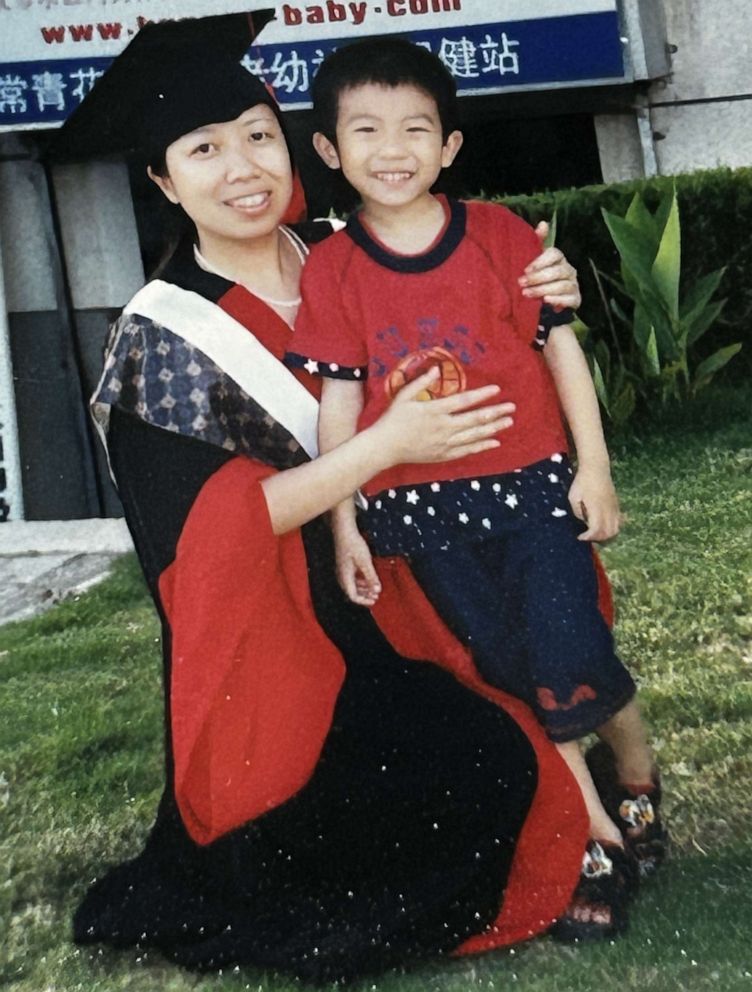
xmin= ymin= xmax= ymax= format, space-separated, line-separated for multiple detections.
xmin=312 ymin=35 xmax=459 ymax=144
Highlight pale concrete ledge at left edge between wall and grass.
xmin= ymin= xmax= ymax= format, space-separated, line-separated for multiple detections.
xmin=0 ymin=517 xmax=133 ymax=557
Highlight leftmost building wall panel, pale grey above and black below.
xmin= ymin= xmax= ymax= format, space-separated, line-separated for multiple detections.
xmin=0 ymin=135 xmax=96 ymax=520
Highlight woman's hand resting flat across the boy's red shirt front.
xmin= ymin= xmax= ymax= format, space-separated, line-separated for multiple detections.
xmin=368 ymin=368 xmax=515 ymax=468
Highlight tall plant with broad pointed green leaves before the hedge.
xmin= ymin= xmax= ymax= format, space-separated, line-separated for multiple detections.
xmin=580 ymin=188 xmax=741 ymax=422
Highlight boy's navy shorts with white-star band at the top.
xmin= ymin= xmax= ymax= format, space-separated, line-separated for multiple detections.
xmin=362 ymin=454 xmax=635 ymax=741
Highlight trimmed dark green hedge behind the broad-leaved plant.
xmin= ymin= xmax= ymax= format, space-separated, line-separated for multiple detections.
xmin=496 ymin=168 xmax=752 ymax=377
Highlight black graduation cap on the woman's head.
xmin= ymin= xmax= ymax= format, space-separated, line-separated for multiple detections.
xmin=49 ymin=14 xmax=278 ymax=162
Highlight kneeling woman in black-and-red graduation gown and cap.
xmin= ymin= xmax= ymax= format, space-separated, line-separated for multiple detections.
xmin=64 ymin=19 xmax=587 ymax=980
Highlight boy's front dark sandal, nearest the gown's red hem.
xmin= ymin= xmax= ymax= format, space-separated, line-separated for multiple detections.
xmin=548 ymin=840 xmax=639 ymax=942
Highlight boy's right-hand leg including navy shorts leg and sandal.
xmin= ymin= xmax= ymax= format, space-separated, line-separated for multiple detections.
xmin=525 ymin=520 xmax=667 ymax=875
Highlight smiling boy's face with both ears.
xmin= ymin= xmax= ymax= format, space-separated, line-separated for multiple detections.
xmin=313 ymin=83 xmax=462 ymax=209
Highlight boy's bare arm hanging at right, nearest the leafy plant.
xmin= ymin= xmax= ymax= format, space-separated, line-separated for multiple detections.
xmin=543 ymin=324 xmax=619 ymax=541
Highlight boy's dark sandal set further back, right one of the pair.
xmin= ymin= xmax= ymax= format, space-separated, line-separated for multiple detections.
xmin=585 ymin=741 xmax=669 ymax=877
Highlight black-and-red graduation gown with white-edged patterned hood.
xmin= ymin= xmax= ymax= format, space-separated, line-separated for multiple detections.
xmin=74 ymin=227 xmax=587 ymax=981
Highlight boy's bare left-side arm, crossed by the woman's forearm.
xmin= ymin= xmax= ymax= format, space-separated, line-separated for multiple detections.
xmin=319 ymin=378 xmax=381 ymax=606
